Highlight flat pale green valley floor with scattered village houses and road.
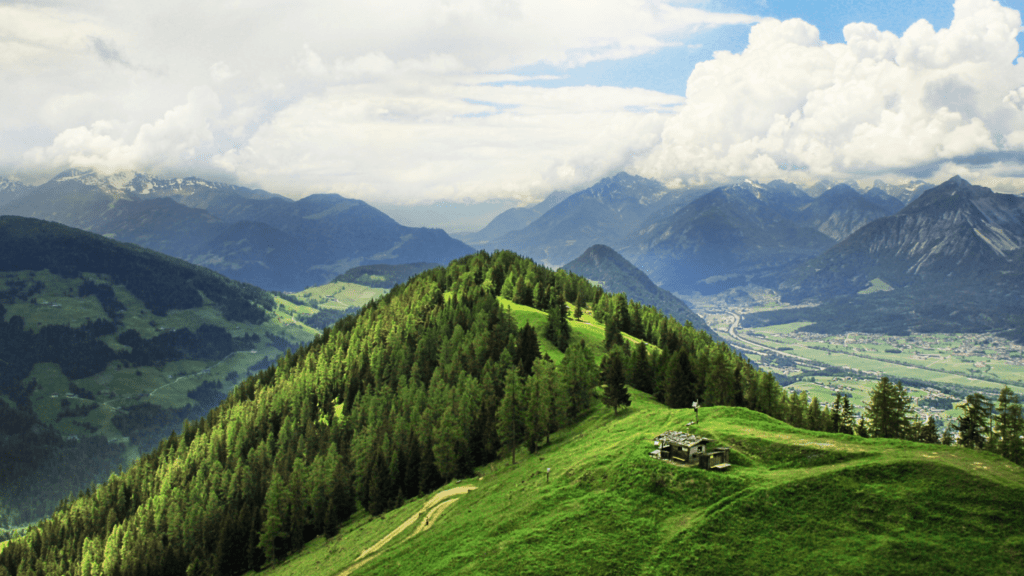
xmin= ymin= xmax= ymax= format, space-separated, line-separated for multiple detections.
xmin=687 ymin=294 xmax=1024 ymax=430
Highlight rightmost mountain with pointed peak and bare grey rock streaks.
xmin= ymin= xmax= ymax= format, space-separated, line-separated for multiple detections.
xmin=780 ymin=176 xmax=1024 ymax=338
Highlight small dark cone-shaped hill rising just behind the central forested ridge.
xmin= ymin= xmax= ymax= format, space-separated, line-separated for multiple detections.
xmin=562 ymin=244 xmax=715 ymax=335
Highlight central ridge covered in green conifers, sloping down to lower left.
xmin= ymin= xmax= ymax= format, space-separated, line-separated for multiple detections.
xmin=0 ymin=252 xmax=937 ymax=576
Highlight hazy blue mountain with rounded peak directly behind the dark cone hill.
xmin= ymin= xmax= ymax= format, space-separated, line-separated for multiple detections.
xmin=493 ymin=172 xmax=700 ymax=266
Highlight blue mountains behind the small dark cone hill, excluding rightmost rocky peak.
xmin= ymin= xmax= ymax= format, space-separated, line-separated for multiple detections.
xmin=475 ymin=173 xmax=927 ymax=293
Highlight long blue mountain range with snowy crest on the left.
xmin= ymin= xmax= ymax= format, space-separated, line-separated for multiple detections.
xmin=0 ymin=170 xmax=472 ymax=291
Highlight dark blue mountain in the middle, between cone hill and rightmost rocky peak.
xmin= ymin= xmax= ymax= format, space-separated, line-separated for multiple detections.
xmin=620 ymin=182 xmax=834 ymax=293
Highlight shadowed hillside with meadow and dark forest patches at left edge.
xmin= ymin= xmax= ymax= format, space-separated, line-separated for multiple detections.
xmin=0 ymin=216 xmax=381 ymax=522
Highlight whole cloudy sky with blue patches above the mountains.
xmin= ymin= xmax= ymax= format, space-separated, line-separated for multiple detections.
xmin=0 ymin=0 xmax=1024 ymax=222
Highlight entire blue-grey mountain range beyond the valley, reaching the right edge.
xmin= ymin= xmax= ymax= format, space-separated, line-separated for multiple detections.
xmin=462 ymin=174 xmax=1024 ymax=338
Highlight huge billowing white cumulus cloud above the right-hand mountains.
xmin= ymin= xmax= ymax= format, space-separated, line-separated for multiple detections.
xmin=634 ymin=0 xmax=1024 ymax=188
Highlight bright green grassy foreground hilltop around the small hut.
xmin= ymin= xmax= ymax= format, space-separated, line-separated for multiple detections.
xmin=261 ymin=390 xmax=1024 ymax=576
